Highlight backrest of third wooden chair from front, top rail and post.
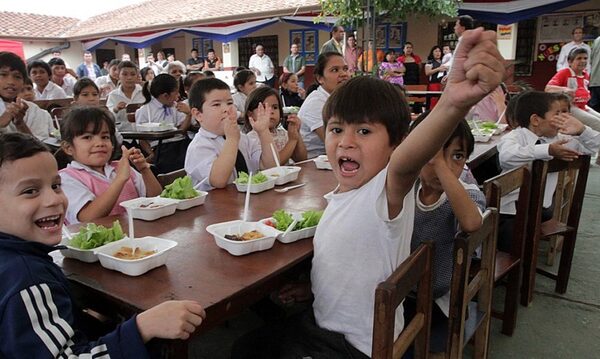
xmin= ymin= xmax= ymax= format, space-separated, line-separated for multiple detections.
xmin=483 ymin=166 xmax=531 ymax=258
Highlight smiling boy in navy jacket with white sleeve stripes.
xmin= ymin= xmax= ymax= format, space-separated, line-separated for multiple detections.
xmin=0 ymin=133 xmax=205 ymax=358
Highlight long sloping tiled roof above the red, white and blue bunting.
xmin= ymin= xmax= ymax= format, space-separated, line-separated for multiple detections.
xmin=65 ymin=0 xmax=320 ymax=38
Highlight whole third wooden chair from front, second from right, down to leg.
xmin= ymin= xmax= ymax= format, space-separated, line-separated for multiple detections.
xmin=483 ymin=166 xmax=531 ymax=335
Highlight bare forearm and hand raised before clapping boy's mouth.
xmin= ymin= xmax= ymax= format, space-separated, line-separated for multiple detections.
xmin=209 ymin=106 xmax=240 ymax=188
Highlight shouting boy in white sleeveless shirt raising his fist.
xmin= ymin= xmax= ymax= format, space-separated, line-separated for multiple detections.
xmin=232 ymin=29 xmax=504 ymax=359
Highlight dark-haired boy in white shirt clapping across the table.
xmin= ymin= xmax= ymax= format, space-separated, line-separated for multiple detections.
xmin=185 ymin=78 xmax=275 ymax=191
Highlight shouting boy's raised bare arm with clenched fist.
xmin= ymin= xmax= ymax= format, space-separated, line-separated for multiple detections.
xmin=386 ymin=28 xmax=504 ymax=218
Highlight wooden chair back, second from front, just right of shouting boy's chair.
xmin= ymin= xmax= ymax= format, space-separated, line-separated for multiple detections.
xmin=446 ymin=208 xmax=498 ymax=359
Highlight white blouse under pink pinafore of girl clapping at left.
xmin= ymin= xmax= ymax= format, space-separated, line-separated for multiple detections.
xmin=60 ymin=160 xmax=146 ymax=224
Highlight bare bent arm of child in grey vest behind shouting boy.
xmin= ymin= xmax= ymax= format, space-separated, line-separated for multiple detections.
xmin=426 ymin=150 xmax=482 ymax=233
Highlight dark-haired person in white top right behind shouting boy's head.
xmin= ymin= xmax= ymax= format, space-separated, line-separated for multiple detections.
xmin=298 ymin=52 xmax=349 ymax=158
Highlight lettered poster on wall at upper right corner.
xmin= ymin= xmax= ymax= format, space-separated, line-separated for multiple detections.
xmin=538 ymin=10 xmax=600 ymax=43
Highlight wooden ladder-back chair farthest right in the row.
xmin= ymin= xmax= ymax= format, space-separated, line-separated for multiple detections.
xmin=521 ymin=155 xmax=590 ymax=306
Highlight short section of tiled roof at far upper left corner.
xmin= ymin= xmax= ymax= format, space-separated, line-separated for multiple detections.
xmin=0 ymin=11 xmax=80 ymax=38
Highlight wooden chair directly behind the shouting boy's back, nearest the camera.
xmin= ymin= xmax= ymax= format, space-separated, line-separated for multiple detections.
xmin=372 ymin=243 xmax=433 ymax=359
